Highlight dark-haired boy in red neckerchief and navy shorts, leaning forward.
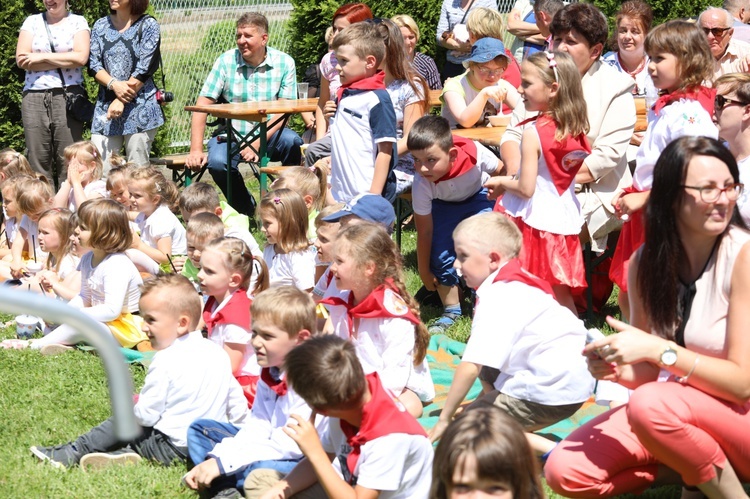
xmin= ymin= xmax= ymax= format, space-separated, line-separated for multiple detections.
xmin=407 ymin=116 xmax=502 ymax=334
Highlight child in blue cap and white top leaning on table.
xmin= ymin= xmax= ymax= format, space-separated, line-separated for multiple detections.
xmin=440 ymin=38 xmax=521 ymax=128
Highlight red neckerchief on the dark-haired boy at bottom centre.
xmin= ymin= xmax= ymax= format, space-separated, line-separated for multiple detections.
xmin=339 ymin=373 xmax=427 ymax=476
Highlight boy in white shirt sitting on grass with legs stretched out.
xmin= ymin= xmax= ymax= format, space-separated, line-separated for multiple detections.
xmin=31 ymin=275 xmax=247 ymax=468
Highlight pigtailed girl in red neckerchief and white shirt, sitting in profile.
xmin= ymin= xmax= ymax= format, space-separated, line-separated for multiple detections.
xmin=198 ymin=237 xmax=268 ymax=407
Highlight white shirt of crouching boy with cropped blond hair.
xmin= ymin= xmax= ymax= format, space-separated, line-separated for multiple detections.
xmin=462 ymin=271 xmax=594 ymax=406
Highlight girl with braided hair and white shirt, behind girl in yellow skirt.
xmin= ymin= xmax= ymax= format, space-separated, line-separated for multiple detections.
xmin=128 ymin=166 xmax=187 ymax=268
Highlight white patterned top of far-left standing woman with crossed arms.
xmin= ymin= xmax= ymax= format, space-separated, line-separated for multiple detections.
xmin=21 ymin=14 xmax=90 ymax=90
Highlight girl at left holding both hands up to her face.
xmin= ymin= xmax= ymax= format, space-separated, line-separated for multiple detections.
xmin=55 ymin=140 xmax=107 ymax=213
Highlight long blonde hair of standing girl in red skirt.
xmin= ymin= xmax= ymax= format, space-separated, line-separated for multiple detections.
xmin=524 ymin=51 xmax=589 ymax=140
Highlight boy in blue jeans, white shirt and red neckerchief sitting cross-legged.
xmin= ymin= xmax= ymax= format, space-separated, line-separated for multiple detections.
xmin=184 ymin=286 xmax=315 ymax=497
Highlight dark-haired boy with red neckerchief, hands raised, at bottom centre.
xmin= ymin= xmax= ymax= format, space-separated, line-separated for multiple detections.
xmin=245 ymin=335 xmax=433 ymax=499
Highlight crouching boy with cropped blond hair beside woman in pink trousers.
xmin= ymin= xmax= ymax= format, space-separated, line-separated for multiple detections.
xmin=430 ymin=212 xmax=594 ymax=441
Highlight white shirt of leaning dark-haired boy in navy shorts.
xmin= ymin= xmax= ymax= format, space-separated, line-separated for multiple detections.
xmin=411 ymin=141 xmax=498 ymax=215
